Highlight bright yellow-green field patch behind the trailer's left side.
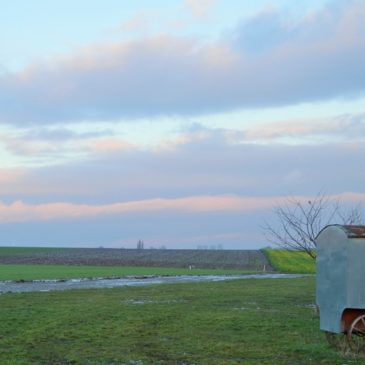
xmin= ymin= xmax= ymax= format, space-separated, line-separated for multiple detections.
xmin=262 ymin=249 xmax=316 ymax=274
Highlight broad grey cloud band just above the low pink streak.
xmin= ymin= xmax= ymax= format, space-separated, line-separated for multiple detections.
xmin=0 ymin=132 xmax=365 ymax=203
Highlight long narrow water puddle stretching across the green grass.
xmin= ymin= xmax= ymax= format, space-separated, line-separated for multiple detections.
xmin=0 ymin=274 xmax=306 ymax=294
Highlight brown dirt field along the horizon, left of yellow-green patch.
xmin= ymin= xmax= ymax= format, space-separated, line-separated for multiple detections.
xmin=0 ymin=248 xmax=272 ymax=271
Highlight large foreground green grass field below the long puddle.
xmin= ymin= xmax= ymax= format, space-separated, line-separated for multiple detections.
xmin=0 ymin=277 xmax=358 ymax=365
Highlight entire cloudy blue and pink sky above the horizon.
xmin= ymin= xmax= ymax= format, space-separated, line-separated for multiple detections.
xmin=0 ymin=0 xmax=365 ymax=249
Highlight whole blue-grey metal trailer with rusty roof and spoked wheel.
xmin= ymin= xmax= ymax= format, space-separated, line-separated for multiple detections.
xmin=316 ymin=225 xmax=365 ymax=354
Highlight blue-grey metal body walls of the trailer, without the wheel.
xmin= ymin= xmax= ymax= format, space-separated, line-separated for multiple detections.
xmin=316 ymin=225 xmax=365 ymax=333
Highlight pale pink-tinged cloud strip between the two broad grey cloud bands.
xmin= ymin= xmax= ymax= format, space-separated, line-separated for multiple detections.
xmin=0 ymin=113 xmax=365 ymax=166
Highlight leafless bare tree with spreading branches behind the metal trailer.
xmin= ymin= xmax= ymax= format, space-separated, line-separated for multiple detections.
xmin=262 ymin=193 xmax=363 ymax=259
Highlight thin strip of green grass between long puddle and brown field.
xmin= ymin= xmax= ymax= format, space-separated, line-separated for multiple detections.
xmin=0 ymin=264 xmax=256 ymax=281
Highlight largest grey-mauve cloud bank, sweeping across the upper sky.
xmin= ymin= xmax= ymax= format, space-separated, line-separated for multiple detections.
xmin=0 ymin=1 xmax=365 ymax=126
